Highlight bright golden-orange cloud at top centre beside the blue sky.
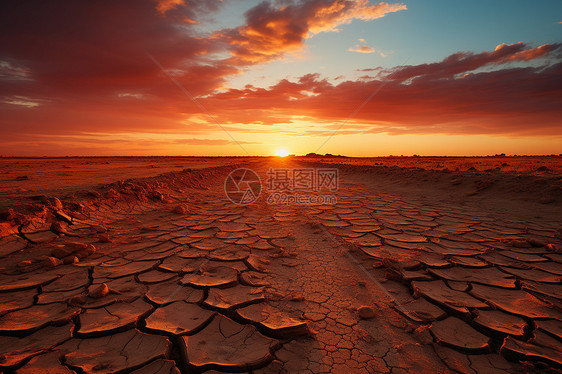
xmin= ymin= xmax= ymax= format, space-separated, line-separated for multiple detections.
xmin=214 ymin=0 xmax=406 ymax=65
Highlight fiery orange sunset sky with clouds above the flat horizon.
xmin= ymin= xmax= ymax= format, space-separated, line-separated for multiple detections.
xmin=0 ymin=0 xmax=562 ymax=156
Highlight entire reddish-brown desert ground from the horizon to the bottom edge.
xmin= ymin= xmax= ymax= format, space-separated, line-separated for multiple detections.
xmin=0 ymin=156 xmax=562 ymax=374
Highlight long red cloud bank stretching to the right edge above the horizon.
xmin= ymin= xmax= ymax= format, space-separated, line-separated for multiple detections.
xmin=201 ymin=44 xmax=562 ymax=135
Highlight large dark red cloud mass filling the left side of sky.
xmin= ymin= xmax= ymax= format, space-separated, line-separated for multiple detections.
xmin=0 ymin=0 xmax=239 ymax=139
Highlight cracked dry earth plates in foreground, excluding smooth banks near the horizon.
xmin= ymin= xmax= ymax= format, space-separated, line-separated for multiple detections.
xmin=0 ymin=162 xmax=562 ymax=374
